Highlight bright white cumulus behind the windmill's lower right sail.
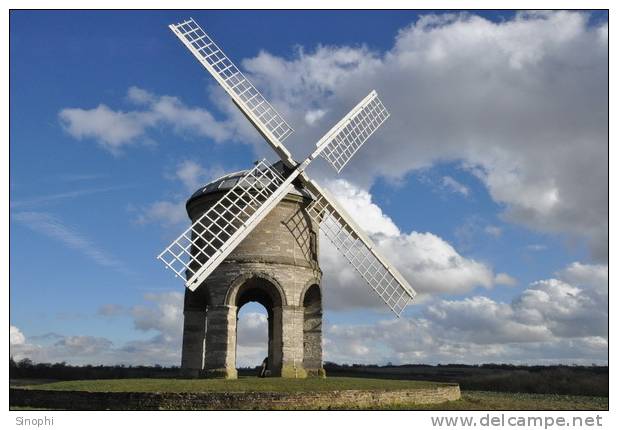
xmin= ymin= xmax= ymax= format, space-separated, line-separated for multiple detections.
xmin=320 ymin=179 xmax=494 ymax=309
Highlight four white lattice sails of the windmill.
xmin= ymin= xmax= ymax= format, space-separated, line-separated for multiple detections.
xmin=157 ymin=18 xmax=416 ymax=378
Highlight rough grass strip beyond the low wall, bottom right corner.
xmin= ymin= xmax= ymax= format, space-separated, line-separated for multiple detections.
xmin=360 ymin=391 xmax=609 ymax=411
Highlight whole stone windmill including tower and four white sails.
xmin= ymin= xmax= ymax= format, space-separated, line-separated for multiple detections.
xmin=158 ymin=19 xmax=415 ymax=378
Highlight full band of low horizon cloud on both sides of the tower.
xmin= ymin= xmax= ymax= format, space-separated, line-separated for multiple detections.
xmin=10 ymin=263 xmax=608 ymax=366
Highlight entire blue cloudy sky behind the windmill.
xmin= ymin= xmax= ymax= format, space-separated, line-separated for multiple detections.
xmin=9 ymin=11 xmax=608 ymax=366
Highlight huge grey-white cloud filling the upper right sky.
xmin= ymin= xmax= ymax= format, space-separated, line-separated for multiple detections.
xmin=237 ymin=12 xmax=608 ymax=261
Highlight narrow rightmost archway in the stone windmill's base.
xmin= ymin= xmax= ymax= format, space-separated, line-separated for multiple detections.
xmin=302 ymin=284 xmax=323 ymax=376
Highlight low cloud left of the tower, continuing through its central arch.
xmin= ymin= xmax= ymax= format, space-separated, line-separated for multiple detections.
xmin=10 ymin=291 xmax=268 ymax=366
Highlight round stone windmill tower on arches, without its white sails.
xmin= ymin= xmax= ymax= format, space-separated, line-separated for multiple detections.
xmin=182 ymin=166 xmax=322 ymax=378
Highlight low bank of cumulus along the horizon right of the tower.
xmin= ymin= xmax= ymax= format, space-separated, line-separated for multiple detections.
xmin=325 ymin=263 xmax=608 ymax=364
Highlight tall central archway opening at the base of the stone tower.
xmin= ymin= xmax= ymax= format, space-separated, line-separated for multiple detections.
xmin=233 ymin=276 xmax=283 ymax=375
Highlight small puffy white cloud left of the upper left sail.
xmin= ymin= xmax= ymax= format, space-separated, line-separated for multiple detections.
xmin=58 ymin=87 xmax=233 ymax=154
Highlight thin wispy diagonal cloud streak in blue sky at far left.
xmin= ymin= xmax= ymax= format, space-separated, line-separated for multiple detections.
xmin=11 ymin=211 xmax=128 ymax=273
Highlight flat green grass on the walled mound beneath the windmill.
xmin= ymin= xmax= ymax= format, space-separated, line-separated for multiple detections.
xmin=22 ymin=377 xmax=443 ymax=393
